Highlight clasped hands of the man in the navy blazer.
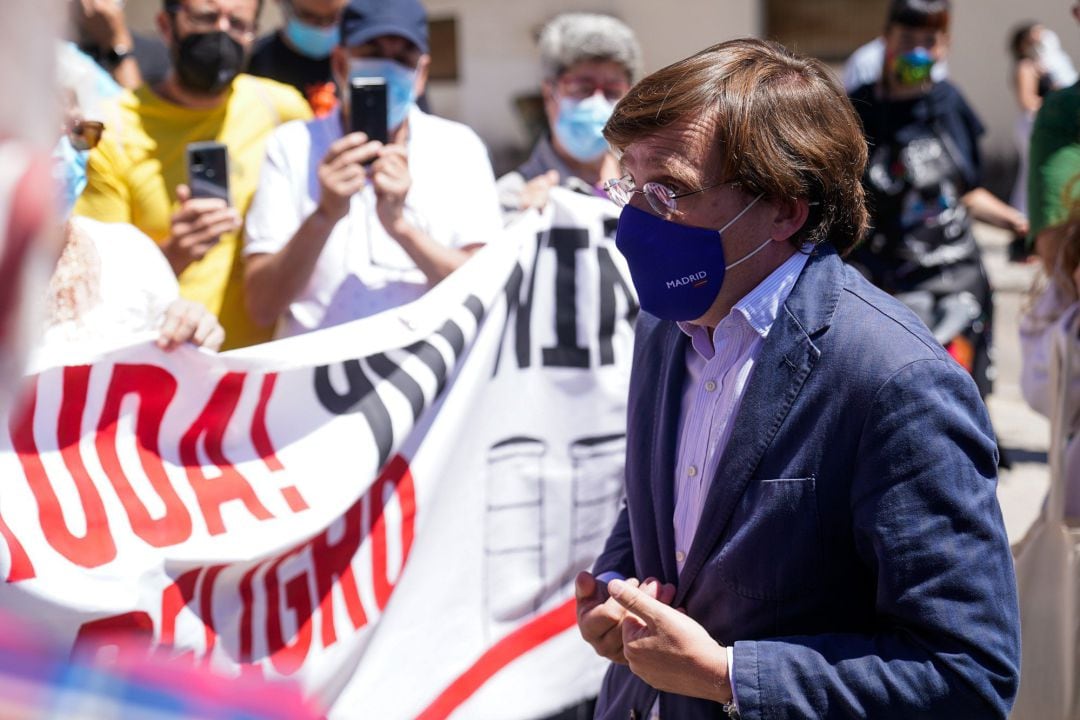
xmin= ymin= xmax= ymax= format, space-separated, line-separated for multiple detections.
xmin=575 ymin=572 xmax=731 ymax=703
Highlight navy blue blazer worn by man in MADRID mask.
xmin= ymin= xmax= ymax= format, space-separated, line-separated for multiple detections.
xmin=594 ymin=247 xmax=1020 ymax=720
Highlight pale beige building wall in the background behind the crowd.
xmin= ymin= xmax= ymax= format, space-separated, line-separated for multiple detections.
xmin=124 ymin=0 xmax=1080 ymax=185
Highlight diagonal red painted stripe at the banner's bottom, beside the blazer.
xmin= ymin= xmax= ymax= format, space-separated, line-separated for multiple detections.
xmin=417 ymin=598 xmax=578 ymax=720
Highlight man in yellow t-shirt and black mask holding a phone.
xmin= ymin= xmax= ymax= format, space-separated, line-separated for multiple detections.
xmin=75 ymin=0 xmax=311 ymax=349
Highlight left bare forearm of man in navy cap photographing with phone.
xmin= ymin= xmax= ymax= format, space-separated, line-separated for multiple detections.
xmin=244 ymin=209 xmax=336 ymax=327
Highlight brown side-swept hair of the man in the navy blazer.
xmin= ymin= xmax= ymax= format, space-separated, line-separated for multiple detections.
xmin=604 ymin=38 xmax=868 ymax=255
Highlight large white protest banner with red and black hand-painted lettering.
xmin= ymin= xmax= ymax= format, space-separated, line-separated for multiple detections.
xmin=0 ymin=190 xmax=637 ymax=720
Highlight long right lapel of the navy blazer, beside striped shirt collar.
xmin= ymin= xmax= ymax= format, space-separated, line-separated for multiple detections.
xmin=669 ymin=248 xmax=842 ymax=607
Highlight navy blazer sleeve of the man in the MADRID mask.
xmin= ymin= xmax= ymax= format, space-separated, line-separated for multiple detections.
xmin=733 ymin=357 xmax=1020 ymax=720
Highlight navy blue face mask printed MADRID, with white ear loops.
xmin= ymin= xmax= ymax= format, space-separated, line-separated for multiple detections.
xmin=615 ymin=195 xmax=772 ymax=321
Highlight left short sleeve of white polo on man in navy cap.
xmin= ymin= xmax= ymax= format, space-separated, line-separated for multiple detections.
xmin=244 ymin=121 xmax=311 ymax=257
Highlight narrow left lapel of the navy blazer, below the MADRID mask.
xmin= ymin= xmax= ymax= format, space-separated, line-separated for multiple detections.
xmin=640 ymin=323 xmax=687 ymax=583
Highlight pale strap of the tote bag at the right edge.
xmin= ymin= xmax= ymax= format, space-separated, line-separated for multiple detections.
xmin=1047 ymin=307 xmax=1080 ymax=525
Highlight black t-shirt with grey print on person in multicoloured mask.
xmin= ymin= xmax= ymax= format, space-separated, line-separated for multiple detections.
xmin=851 ymin=82 xmax=984 ymax=290
